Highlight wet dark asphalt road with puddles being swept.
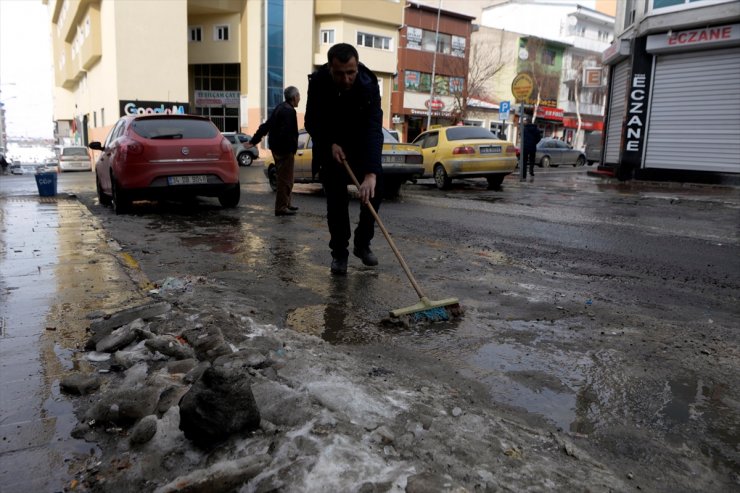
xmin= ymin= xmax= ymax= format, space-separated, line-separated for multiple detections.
xmin=2 ymin=164 xmax=740 ymax=489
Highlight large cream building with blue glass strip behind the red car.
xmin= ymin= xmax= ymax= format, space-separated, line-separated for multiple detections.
xmin=44 ymin=0 xmax=404 ymax=150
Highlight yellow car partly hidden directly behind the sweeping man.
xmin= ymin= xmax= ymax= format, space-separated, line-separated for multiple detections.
xmin=264 ymin=128 xmax=424 ymax=198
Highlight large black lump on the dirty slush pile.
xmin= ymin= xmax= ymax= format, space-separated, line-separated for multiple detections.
xmin=180 ymin=366 xmax=260 ymax=448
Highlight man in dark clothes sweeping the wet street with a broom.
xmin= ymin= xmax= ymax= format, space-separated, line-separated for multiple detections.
xmin=305 ymin=43 xmax=383 ymax=275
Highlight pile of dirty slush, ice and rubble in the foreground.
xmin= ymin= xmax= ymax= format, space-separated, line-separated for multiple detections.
xmin=60 ymin=280 xmax=634 ymax=493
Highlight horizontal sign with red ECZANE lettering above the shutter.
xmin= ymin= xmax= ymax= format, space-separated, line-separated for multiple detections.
xmin=646 ymin=24 xmax=740 ymax=53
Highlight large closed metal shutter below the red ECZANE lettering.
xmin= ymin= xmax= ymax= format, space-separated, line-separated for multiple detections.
xmin=644 ymin=48 xmax=740 ymax=173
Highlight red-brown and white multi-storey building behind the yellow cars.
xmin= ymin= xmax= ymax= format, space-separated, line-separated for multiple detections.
xmin=391 ymin=2 xmax=474 ymax=141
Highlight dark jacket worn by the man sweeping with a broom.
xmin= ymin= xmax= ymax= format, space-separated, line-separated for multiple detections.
xmin=305 ymin=63 xmax=383 ymax=181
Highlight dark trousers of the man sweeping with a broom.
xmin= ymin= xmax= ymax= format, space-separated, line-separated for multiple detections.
xmin=321 ymin=167 xmax=383 ymax=259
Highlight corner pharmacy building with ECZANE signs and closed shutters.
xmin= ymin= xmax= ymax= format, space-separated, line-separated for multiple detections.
xmin=602 ymin=0 xmax=740 ymax=179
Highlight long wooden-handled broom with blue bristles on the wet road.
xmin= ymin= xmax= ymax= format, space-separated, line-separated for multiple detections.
xmin=342 ymin=159 xmax=462 ymax=322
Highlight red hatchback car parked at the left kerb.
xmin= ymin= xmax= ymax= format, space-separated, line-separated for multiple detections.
xmin=88 ymin=115 xmax=241 ymax=214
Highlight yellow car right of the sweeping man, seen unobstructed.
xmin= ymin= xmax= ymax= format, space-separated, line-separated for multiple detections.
xmin=413 ymin=126 xmax=517 ymax=190
